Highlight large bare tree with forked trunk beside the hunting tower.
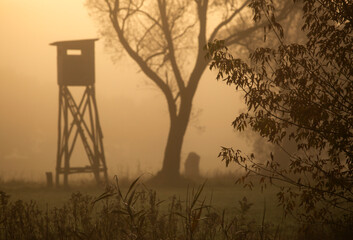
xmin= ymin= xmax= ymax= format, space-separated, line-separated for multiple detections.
xmin=87 ymin=0 xmax=292 ymax=182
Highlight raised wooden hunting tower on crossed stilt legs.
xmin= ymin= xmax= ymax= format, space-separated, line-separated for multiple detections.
xmin=50 ymin=39 xmax=107 ymax=186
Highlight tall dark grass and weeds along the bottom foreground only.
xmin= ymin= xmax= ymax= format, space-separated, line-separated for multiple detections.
xmin=0 ymin=179 xmax=278 ymax=240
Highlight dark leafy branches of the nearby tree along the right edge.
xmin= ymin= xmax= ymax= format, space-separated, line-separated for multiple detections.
xmin=208 ymin=0 xmax=353 ymax=222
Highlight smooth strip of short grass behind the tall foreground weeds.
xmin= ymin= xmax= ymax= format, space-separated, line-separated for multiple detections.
xmin=0 ymin=175 xmax=281 ymax=213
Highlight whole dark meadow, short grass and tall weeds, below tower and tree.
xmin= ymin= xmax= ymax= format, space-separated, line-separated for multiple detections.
xmin=0 ymin=176 xmax=340 ymax=239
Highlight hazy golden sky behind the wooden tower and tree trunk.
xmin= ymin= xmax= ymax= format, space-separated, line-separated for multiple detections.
xmin=0 ymin=0 xmax=250 ymax=179
